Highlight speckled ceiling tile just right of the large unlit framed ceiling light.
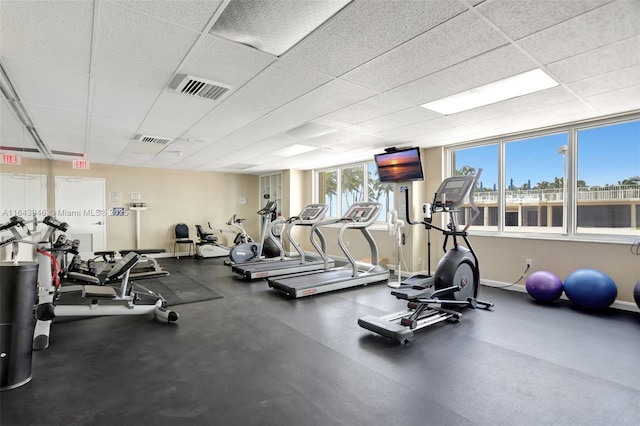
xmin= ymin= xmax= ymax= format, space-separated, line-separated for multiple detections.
xmin=283 ymin=0 xmax=465 ymax=76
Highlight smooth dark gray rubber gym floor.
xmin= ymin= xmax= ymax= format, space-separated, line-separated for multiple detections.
xmin=0 ymin=259 xmax=640 ymax=426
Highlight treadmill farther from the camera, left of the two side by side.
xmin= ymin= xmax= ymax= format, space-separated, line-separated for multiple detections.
xmin=232 ymin=204 xmax=335 ymax=280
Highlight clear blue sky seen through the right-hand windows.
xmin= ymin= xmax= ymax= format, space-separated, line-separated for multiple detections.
xmin=456 ymin=121 xmax=640 ymax=188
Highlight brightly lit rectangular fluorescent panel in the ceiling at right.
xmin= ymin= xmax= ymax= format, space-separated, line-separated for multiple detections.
xmin=420 ymin=68 xmax=558 ymax=115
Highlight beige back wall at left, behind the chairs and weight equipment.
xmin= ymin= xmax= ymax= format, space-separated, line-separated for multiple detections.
xmin=0 ymin=159 xmax=260 ymax=252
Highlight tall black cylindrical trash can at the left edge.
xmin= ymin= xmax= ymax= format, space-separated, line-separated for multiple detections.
xmin=0 ymin=262 xmax=38 ymax=391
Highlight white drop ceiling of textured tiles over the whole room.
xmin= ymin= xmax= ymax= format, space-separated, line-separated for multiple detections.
xmin=0 ymin=0 xmax=640 ymax=174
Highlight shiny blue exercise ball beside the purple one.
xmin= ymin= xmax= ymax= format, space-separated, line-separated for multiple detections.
xmin=564 ymin=268 xmax=618 ymax=309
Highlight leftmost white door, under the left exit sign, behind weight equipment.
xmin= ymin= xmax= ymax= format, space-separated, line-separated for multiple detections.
xmin=0 ymin=173 xmax=48 ymax=261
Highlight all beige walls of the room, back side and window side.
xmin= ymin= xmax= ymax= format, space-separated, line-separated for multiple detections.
xmin=0 ymin=154 xmax=640 ymax=303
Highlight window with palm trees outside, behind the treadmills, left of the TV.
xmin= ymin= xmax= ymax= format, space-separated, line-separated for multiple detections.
xmin=316 ymin=162 xmax=394 ymax=221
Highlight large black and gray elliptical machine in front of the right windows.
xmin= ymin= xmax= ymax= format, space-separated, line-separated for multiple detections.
xmin=358 ymin=169 xmax=493 ymax=343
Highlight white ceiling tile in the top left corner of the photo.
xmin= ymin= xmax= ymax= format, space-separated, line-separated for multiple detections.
xmin=0 ymin=0 xmax=93 ymax=73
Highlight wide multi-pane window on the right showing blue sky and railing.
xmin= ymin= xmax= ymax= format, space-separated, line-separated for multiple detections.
xmin=450 ymin=115 xmax=640 ymax=238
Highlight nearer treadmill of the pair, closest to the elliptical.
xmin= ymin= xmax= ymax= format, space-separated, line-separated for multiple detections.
xmin=268 ymin=202 xmax=389 ymax=298
